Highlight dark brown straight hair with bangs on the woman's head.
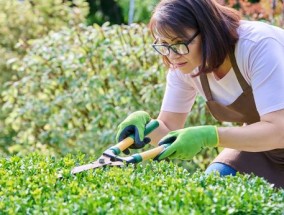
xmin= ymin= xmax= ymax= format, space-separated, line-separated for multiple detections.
xmin=149 ymin=0 xmax=240 ymax=74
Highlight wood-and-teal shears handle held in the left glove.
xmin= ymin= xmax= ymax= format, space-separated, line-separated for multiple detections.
xmin=110 ymin=120 xmax=159 ymax=155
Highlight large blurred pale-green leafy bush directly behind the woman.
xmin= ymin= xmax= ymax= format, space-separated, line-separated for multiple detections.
xmin=1 ymin=24 xmax=219 ymax=159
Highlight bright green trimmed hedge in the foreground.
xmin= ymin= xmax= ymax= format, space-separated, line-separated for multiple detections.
xmin=0 ymin=154 xmax=284 ymax=215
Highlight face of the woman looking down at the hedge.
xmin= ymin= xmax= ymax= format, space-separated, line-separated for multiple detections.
xmin=154 ymin=29 xmax=202 ymax=74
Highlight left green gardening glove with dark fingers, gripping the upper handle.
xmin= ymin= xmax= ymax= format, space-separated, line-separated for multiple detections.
xmin=116 ymin=111 xmax=151 ymax=154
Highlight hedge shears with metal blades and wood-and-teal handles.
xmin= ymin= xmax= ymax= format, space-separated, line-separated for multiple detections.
xmin=58 ymin=120 xmax=169 ymax=178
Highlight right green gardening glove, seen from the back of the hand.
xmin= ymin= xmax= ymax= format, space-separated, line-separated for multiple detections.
xmin=157 ymin=125 xmax=219 ymax=160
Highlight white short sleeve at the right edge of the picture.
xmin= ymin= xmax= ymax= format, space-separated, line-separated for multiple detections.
xmin=249 ymin=38 xmax=284 ymax=115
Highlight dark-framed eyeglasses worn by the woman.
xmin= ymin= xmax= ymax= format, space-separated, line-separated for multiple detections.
xmin=152 ymin=31 xmax=200 ymax=56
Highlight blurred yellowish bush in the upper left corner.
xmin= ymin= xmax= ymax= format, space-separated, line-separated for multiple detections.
xmin=0 ymin=0 xmax=88 ymax=87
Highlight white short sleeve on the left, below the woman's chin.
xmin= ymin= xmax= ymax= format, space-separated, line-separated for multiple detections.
xmin=161 ymin=70 xmax=196 ymax=113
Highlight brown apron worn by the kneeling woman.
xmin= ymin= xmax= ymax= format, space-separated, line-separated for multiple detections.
xmin=200 ymin=52 xmax=284 ymax=188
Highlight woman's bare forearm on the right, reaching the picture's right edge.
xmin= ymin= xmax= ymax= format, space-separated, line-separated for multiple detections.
xmin=218 ymin=110 xmax=284 ymax=152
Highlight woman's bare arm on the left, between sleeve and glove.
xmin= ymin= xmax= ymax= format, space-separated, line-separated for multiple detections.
xmin=149 ymin=111 xmax=187 ymax=146
